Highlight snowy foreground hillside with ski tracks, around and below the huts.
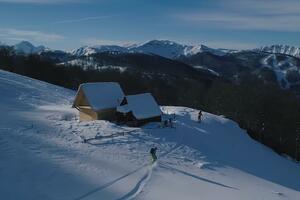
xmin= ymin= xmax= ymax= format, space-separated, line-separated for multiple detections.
xmin=0 ymin=71 xmax=300 ymax=200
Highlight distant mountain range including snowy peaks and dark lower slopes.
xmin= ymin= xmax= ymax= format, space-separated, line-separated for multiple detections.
xmin=0 ymin=40 xmax=300 ymax=94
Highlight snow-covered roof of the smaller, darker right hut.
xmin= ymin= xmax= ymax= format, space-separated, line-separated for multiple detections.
xmin=117 ymin=93 xmax=161 ymax=119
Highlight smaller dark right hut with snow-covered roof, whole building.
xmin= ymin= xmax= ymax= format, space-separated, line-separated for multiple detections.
xmin=117 ymin=93 xmax=162 ymax=126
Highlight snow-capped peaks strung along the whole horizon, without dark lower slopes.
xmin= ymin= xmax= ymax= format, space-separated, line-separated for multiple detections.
xmin=4 ymin=40 xmax=300 ymax=59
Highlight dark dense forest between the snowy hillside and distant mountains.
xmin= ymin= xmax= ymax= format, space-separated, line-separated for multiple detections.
xmin=0 ymin=47 xmax=300 ymax=160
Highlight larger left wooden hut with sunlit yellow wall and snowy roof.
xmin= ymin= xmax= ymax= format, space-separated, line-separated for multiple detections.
xmin=72 ymin=82 xmax=125 ymax=121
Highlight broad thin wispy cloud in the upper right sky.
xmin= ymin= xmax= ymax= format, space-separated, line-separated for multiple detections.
xmin=172 ymin=0 xmax=300 ymax=32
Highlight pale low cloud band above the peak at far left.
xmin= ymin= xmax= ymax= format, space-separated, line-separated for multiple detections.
xmin=0 ymin=29 xmax=64 ymax=42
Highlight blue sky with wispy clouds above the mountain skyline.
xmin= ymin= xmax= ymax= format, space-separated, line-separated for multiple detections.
xmin=0 ymin=0 xmax=300 ymax=50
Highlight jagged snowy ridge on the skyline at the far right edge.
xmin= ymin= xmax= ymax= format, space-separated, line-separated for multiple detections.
xmin=258 ymin=45 xmax=300 ymax=58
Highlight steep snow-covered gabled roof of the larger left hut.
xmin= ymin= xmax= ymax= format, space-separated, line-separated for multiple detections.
xmin=73 ymin=82 xmax=125 ymax=110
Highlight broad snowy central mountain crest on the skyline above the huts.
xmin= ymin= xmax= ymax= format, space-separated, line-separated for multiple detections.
xmin=71 ymin=40 xmax=231 ymax=58
